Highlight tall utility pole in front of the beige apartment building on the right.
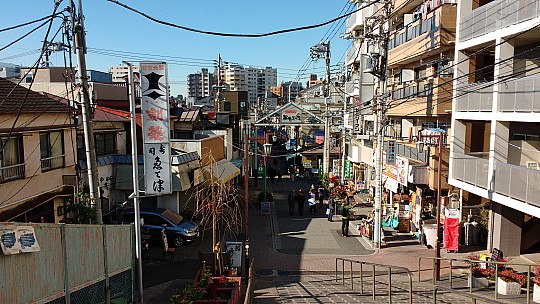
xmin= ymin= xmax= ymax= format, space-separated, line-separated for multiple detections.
xmin=366 ymin=0 xmax=392 ymax=248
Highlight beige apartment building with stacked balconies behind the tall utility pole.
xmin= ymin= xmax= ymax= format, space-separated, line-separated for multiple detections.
xmin=344 ymin=0 xmax=456 ymax=238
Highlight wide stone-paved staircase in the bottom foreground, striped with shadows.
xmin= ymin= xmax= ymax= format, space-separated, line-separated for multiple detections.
xmin=254 ymin=273 xmax=526 ymax=304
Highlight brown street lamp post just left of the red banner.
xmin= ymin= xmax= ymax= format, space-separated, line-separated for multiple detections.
xmin=416 ymin=132 xmax=444 ymax=281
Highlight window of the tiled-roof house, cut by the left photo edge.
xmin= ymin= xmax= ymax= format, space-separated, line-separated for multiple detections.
xmin=0 ymin=136 xmax=25 ymax=183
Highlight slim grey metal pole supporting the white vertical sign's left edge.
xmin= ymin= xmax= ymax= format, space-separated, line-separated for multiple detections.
xmin=123 ymin=61 xmax=144 ymax=304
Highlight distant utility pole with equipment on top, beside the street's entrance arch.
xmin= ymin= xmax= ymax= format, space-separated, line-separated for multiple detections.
xmin=310 ymin=41 xmax=330 ymax=176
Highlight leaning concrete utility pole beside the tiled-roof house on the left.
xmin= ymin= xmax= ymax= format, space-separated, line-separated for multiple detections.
xmin=71 ymin=1 xmax=103 ymax=224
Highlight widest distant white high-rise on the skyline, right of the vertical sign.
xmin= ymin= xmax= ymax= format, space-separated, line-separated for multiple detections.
xmin=221 ymin=64 xmax=277 ymax=106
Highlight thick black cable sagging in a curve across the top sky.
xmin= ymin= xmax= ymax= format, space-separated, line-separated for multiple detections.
xmin=107 ymin=0 xmax=381 ymax=38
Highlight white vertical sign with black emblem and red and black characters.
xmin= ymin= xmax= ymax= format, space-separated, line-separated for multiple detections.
xmin=140 ymin=62 xmax=172 ymax=195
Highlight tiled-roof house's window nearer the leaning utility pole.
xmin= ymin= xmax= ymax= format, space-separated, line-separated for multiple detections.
xmin=39 ymin=131 xmax=64 ymax=171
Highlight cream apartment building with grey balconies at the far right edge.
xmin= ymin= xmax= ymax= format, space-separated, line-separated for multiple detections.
xmin=449 ymin=0 xmax=540 ymax=256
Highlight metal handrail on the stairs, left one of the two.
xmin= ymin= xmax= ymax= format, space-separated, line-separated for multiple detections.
xmin=336 ymin=258 xmax=412 ymax=304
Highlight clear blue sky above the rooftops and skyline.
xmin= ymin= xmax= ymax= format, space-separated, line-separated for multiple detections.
xmin=0 ymin=0 xmax=353 ymax=95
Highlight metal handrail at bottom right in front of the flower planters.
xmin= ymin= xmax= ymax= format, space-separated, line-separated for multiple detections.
xmin=418 ymin=257 xmax=540 ymax=304
